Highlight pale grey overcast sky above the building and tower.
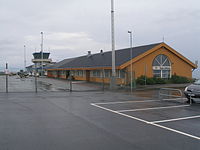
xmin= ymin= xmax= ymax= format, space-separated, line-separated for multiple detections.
xmin=0 ymin=0 xmax=200 ymax=77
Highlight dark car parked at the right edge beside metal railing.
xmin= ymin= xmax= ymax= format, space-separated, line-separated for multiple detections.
xmin=184 ymin=80 xmax=200 ymax=103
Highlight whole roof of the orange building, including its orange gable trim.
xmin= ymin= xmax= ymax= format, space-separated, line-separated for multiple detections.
xmin=49 ymin=43 xmax=197 ymax=70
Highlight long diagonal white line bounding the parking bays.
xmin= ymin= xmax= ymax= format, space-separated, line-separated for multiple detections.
xmin=91 ymin=103 xmax=200 ymax=140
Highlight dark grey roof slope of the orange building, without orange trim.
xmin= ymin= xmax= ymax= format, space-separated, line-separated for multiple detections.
xmin=50 ymin=43 xmax=160 ymax=69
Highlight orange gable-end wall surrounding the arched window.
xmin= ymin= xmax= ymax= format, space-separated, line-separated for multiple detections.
xmin=127 ymin=48 xmax=192 ymax=78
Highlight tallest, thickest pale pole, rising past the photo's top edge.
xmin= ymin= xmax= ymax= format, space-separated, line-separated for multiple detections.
xmin=110 ymin=0 xmax=116 ymax=89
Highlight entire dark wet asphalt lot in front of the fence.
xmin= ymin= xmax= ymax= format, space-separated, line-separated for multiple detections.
xmin=0 ymin=77 xmax=200 ymax=150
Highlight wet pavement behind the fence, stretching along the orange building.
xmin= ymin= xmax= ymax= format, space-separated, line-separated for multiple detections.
xmin=0 ymin=76 xmax=186 ymax=98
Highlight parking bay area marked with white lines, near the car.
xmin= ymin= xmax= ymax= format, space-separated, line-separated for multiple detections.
xmin=91 ymin=99 xmax=200 ymax=140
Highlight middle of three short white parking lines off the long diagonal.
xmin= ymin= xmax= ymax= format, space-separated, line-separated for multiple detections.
xmin=117 ymin=105 xmax=190 ymax=112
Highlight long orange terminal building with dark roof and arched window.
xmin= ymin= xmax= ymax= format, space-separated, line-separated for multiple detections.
xmin=47 ymin=42 xmax=197 ymax=85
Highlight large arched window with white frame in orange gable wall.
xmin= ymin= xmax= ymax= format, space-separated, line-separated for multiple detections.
xmin=152 ymin=54 xmax=171 ymax=78
